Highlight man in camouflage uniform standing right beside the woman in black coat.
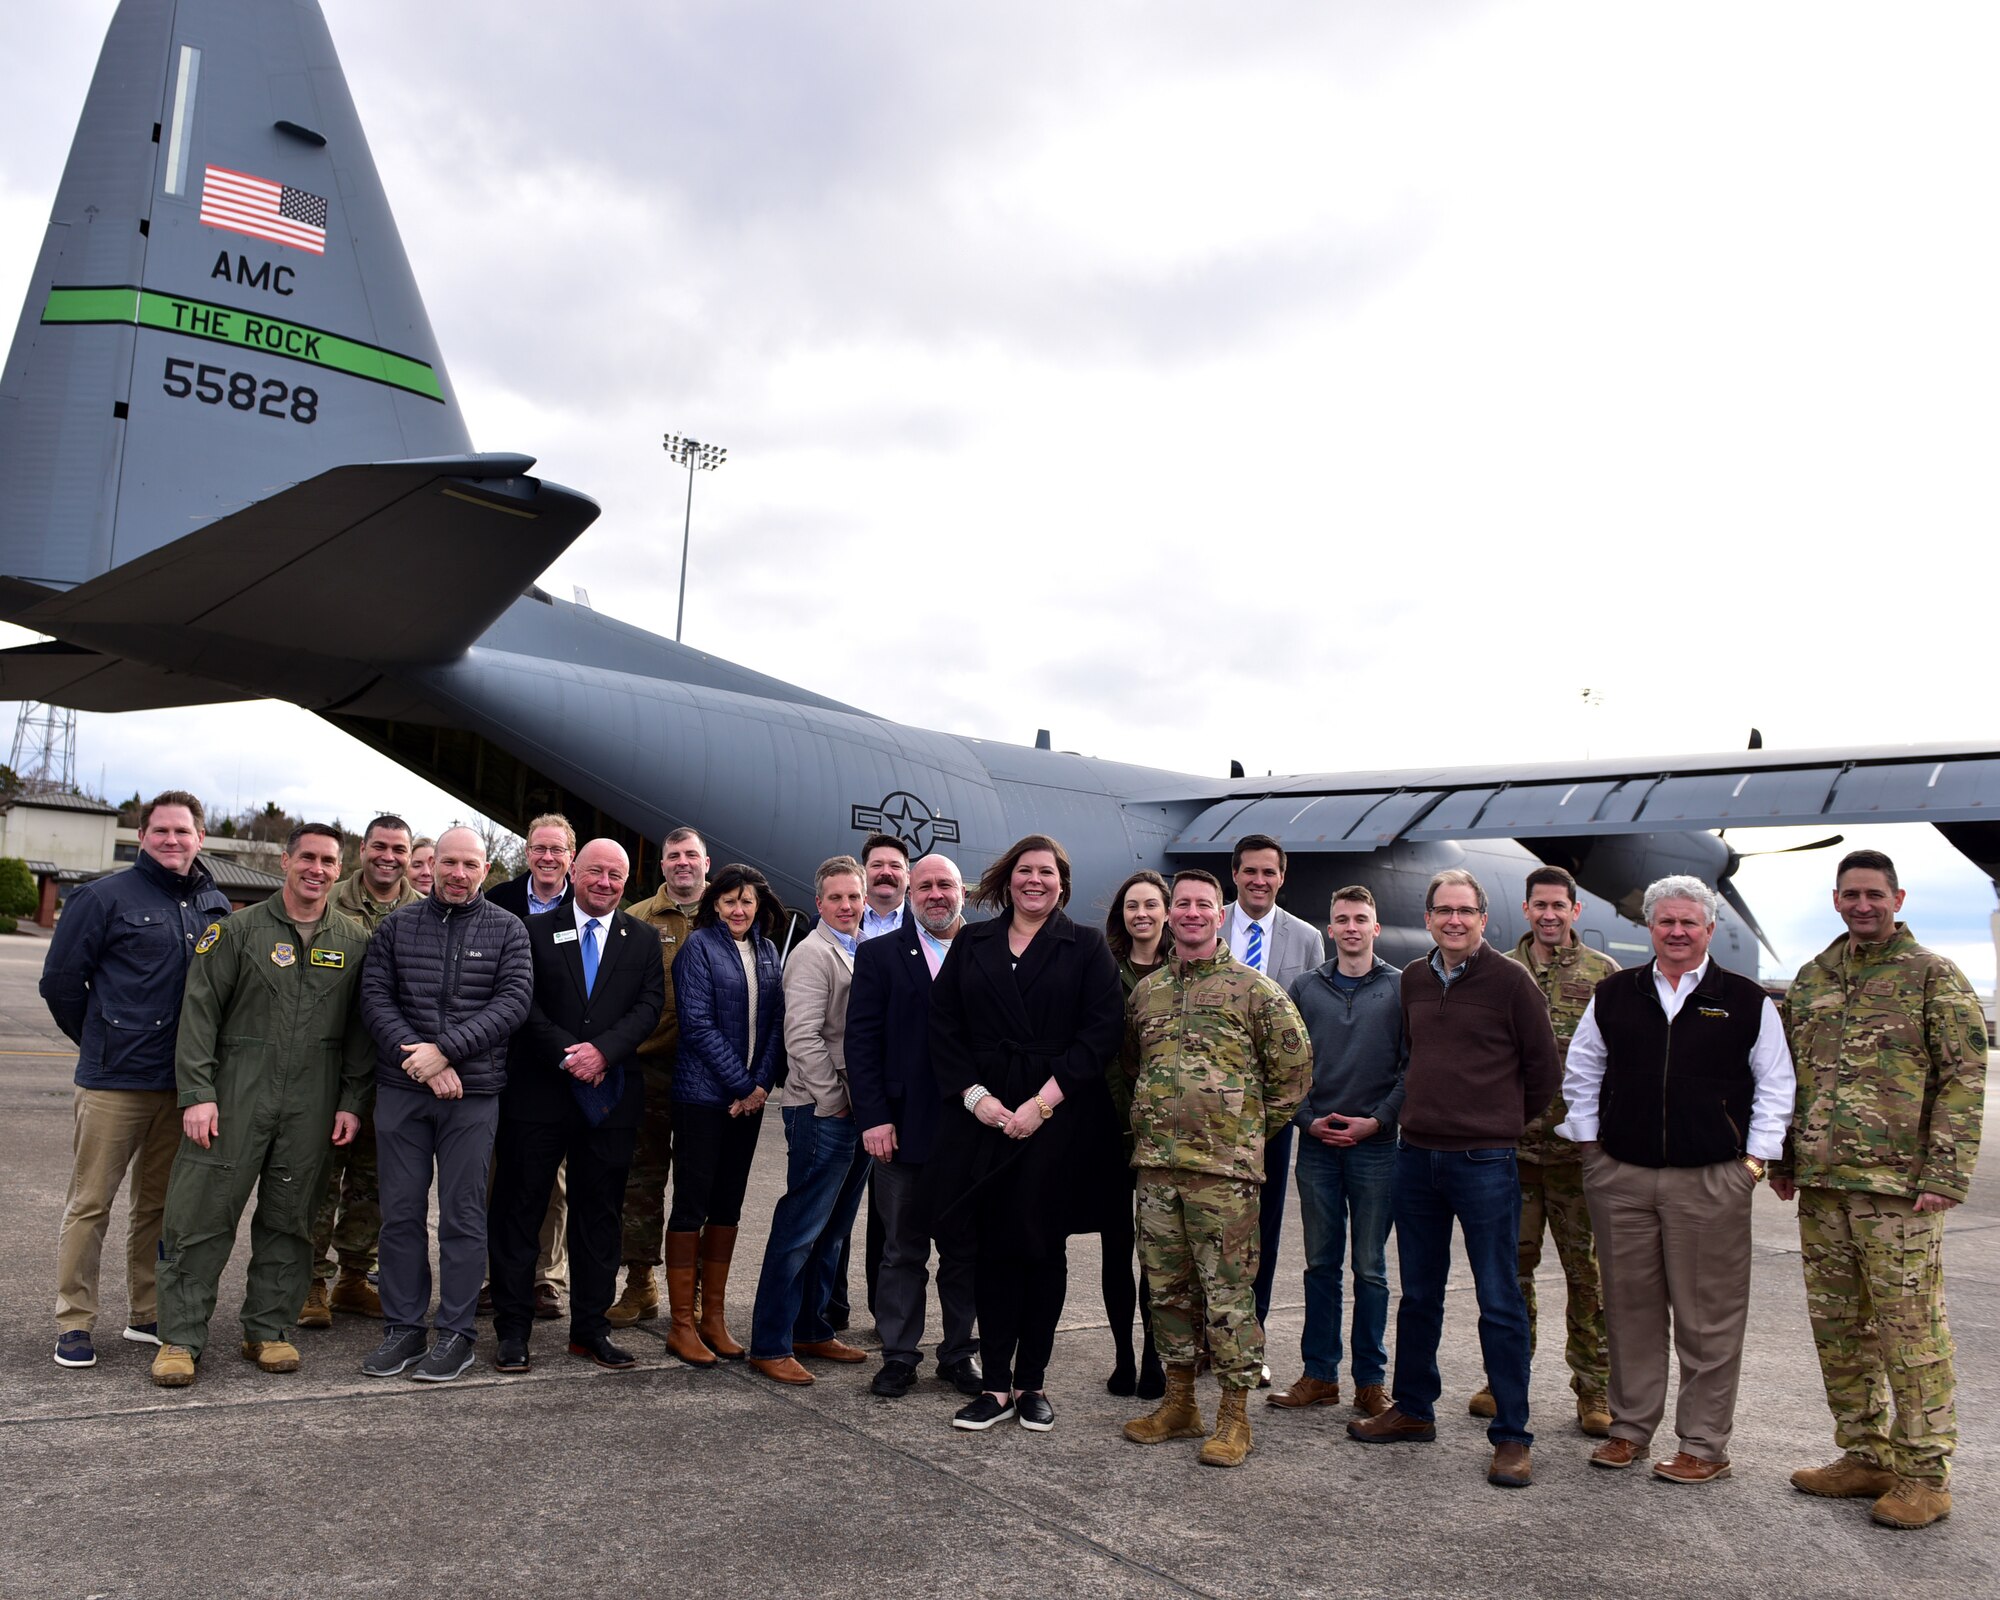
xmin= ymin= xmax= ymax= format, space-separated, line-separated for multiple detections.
xmin=1124 ymin=870 xmax=1312 ymax=1466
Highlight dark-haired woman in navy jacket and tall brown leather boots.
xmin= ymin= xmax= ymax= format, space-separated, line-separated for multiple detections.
xmin=666 ymin=864 xmax=784 ymax=1366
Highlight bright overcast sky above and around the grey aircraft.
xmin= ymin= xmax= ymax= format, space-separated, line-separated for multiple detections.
xmin=0 ymin=0 xmax=2000 ymax=986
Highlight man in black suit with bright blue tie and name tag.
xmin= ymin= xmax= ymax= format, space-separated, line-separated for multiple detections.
xmin=488 ymin=838 xmax=666 ymax=1372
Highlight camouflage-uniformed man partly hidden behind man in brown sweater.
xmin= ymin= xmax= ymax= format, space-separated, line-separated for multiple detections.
xmin=1466 ymin=866 xmax=1618 ymax=1438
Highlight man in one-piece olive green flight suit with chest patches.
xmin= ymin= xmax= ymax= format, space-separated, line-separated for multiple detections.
xmin=152 ymin=822 xmax=374 ymax=1388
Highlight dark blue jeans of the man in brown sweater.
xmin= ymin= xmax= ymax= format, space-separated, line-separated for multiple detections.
xmin=1392 ymin=1144 xmax=1534 ymax=1444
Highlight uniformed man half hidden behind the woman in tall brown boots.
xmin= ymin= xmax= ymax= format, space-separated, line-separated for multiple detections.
xmin=606 ymin=828 xmax=708 ymax=1328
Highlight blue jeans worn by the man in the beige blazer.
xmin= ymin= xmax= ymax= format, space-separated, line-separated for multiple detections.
xmin=750 ymin=1106 xmax=868 ymax=1360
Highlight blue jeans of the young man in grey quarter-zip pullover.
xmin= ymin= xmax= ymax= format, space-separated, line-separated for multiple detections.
xmin=1298 ymin=1134 xmax=1396 ymax=1388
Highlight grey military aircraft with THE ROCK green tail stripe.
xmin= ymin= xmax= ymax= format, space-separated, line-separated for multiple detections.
xmin=0 ymin=0 xmax=2000 ymax=972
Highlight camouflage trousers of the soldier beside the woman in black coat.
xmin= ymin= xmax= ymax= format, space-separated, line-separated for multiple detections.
xmin=1138 ymin=1166 xmax=1264 ymax=1388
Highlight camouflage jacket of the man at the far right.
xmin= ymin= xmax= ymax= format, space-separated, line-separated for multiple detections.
xmin=1776 ymin=922 xmax=1986 ymax=1200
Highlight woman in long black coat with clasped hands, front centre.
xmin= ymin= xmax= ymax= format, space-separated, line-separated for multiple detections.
xmin=930 ymin=834 xmax=1132 ymax=1432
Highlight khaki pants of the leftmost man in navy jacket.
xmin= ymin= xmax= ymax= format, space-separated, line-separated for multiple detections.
xmin=56 ymin=1088 xmax=180 ymax=1334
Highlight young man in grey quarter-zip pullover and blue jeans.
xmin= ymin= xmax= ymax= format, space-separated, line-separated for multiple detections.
xmin=1266 ymin=884 xmax=1408 ymax=1416
